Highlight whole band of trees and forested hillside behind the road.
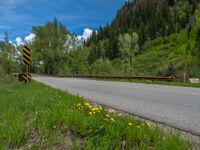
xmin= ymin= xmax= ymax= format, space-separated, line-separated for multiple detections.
xmin=0 ymin=0 xmax=200 ymax=81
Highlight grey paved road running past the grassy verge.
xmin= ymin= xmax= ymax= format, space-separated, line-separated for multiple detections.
xmin=33 ymin=76 xmax=200 ymax=136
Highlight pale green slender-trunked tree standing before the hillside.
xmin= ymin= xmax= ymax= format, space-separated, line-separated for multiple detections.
xmin=118 ymin=32 xmax=139 ymax=75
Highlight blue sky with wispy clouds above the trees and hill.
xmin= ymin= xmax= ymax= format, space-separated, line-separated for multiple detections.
xmin=0 ymin=0 xmax=125 ymax=42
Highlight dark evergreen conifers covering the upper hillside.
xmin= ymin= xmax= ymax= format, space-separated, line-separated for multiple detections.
xmin=86 ymin=0 xmax=196 ymax=62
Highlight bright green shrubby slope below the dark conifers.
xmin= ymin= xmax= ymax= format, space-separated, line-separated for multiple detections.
xmin=113 ymin=5 xmax=200 ymax=79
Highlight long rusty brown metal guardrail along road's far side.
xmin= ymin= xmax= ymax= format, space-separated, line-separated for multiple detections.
xmin=59 ymin=75 xmax=177 ymax=82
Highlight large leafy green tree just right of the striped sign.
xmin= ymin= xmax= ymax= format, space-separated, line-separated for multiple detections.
xmin=32 ymin=18 xmax=69 ymax=75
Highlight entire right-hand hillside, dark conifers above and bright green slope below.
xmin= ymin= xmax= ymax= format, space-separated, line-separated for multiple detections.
xmin=78 ymin=0 xmax=200 ymax=79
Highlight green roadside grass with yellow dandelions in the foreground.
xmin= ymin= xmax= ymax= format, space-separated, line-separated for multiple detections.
xmin=0 ymin=81 xmax=192 ymax=150
